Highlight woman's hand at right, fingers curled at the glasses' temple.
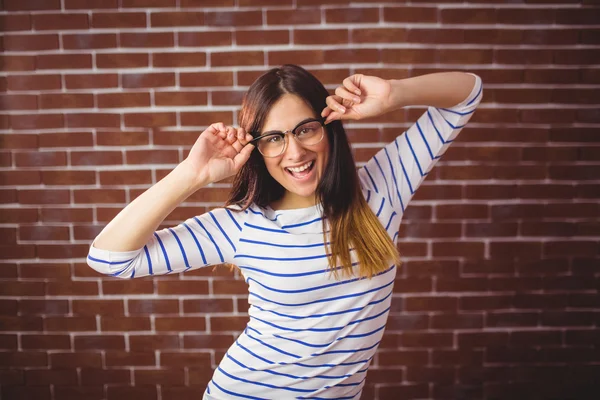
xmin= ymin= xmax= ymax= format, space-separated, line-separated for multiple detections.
xmin=321 ymin=74 xmax=392 ymax=124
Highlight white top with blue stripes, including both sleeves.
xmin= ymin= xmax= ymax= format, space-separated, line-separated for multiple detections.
xmin=87 ymin=77 xmax=482 ymax=400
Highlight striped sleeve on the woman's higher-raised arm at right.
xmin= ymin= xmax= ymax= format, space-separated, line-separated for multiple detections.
xmin=358 ymin=74 xmax=483 ymax=213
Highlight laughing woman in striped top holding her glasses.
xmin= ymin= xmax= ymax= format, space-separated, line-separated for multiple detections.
xmin=88 ymin=65 xmax=482 ymax=399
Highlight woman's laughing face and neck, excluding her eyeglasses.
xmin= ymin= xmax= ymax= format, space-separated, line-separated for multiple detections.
xmin=261 ymin=94 xmax=329 ymax=209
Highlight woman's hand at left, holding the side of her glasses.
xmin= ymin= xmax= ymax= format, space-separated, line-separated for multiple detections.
xmin=182 ymin=122 xmax=254 ymax=185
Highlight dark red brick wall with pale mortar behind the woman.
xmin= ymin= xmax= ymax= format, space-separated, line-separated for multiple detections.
xmin=0 ymin=0 xmax=600 ymax=400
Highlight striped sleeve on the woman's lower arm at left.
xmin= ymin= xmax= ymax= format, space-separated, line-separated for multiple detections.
xmin=87 ymin=208 xmax=245 ymax=279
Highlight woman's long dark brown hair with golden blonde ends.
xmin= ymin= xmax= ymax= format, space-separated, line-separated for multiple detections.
xmin=226 ymin=64 xmax=400 ymax=278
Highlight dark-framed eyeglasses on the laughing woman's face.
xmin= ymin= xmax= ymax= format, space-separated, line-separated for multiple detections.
xmin=250 ymin=118 xmax=325 ymax=157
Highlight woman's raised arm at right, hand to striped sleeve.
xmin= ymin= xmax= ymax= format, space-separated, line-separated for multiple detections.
xmin=324 ymin=72 xmax=482 ymax=213
